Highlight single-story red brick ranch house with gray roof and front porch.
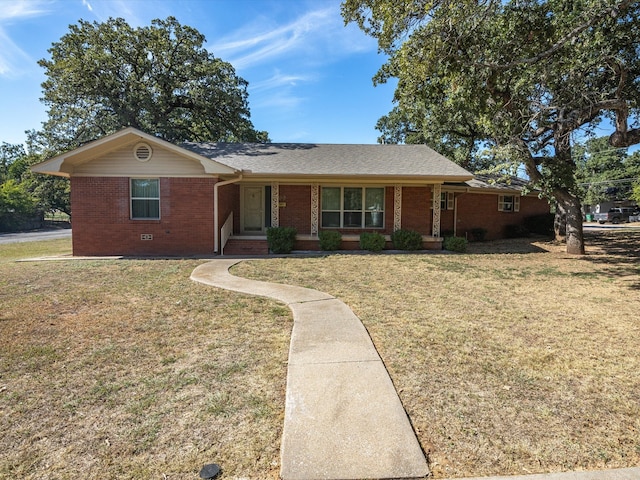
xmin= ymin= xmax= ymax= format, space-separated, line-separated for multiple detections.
xmin=32 ymin=127 xmax=549 ymax=256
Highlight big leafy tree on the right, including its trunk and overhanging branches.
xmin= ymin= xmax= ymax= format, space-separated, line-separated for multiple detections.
xmin=342 ymin=0 xmax=640 ymax=253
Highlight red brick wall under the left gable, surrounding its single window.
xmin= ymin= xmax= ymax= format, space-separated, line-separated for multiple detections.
xmin=71 ymin=177 xmax=216 ymax=255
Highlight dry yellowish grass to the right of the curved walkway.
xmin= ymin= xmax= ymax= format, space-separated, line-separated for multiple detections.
xmin=234 ymin=232 xmax=640 ymax=478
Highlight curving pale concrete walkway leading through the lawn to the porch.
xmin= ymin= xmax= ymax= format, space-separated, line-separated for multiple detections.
xmin=191 ymin=259 xmax=429 ymax=480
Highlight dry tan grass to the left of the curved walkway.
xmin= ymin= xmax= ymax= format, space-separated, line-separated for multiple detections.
xmin=0 ymin=242 xmax=291 ymax=479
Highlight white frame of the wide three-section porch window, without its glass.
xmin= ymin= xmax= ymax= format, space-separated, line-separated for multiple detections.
xmin=319 ymin=185 xmax=386 ymax=230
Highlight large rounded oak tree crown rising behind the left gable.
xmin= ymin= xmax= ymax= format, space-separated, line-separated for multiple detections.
xmin=39 ymin=17 xmax=268 ymax=149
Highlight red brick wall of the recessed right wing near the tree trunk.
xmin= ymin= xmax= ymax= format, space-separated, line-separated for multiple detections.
xmin=456 ymin=193 xmax=549 ymax=240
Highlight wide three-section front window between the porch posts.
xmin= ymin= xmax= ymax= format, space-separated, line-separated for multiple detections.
xmin=322 ymin=187 xmax=384 ymax=228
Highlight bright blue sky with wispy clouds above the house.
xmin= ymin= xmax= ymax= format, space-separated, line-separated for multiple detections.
xmin=0 ymin=0 xmax=394 ymax=143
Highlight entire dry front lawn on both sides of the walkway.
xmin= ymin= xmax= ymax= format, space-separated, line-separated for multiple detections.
xmin=0 ymin=231 xmax=640 ymax=479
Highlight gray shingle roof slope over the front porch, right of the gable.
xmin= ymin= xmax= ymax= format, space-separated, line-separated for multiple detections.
xmin=180 ymin=142 xmax=472 ymax=181
